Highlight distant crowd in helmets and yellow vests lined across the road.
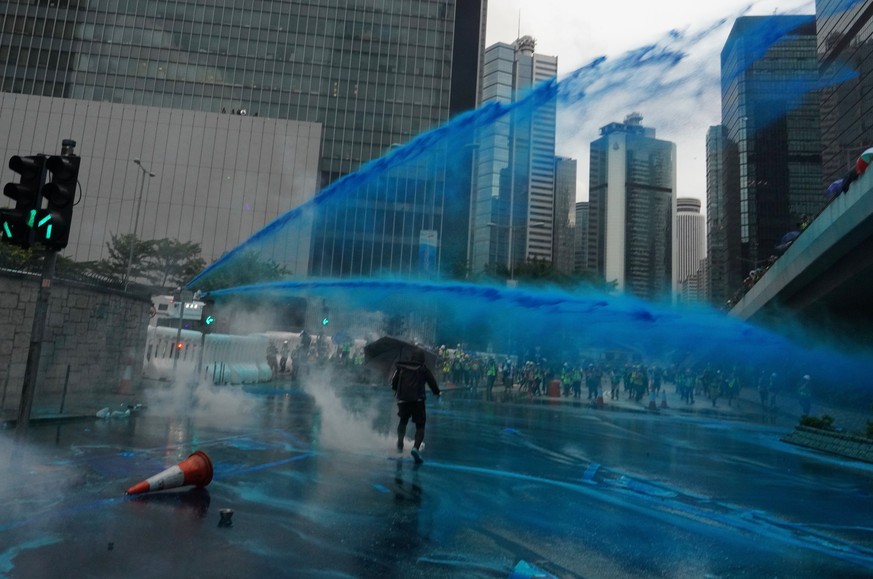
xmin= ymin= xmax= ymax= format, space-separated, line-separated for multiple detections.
xmin=267 ymin=336 xmax=812 ymax=415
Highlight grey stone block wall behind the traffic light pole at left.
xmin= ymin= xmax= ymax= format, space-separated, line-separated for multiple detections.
xmin=0 ymin=271 xmax=151 ymax=414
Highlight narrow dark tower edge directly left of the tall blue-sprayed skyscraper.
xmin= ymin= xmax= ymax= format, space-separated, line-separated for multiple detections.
xmin=705 ymin=125 xmax=739 ymax=307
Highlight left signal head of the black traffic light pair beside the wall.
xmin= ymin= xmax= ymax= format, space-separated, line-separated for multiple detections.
xmin=0 ymin=155 xmax=46 ymax=249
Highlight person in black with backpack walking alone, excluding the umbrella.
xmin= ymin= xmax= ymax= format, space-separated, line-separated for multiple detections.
xmin=391 ymin=348 xmax=440 ymax=464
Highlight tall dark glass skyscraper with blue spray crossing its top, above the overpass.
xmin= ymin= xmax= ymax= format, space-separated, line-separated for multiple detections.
xmin=711 ymin=16 xmax=824 ymax=296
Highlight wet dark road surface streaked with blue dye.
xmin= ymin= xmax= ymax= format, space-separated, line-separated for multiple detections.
xmin=0 ymin=384 xmax=873 ymax=578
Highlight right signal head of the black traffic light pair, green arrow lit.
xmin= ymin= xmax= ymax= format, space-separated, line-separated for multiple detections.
xmin=33 ymin=155 xmax=81 ymax=250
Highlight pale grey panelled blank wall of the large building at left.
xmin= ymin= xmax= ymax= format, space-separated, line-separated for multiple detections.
xmin=0 ymin=93 xmax=321 ymax=273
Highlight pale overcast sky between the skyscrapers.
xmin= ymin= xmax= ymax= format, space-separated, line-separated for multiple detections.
xmin=486 ymin=0 xmax=815 ymax=212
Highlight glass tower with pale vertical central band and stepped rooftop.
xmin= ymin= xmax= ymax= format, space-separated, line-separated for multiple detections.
xmin=588 ymin=113 xmax=676 ymax=299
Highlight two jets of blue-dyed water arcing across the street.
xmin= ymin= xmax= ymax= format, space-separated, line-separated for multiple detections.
xmin=188 ymin=9 xmax=873 ymax=392
